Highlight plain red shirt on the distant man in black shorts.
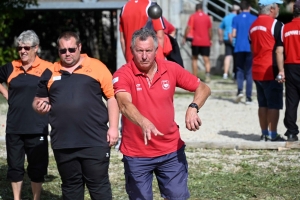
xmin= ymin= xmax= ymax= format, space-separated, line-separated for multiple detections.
xmin=188 ymin=11 xmax=212 ymax=46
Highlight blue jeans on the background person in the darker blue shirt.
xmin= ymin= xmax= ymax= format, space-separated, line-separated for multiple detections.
xmin=235 ymin=52 xmax=253 ymax=99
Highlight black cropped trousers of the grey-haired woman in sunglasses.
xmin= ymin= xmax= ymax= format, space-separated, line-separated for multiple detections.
xmin=5 ymin=134 xmax=48 ymax=183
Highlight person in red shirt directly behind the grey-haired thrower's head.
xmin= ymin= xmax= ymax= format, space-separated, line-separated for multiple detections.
xmin=119 ymin=0 xmax=165 ymax=62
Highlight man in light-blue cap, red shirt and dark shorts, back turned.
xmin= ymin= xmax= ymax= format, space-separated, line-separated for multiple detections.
xmin=249 ymin=0 xmax=284 ymax=141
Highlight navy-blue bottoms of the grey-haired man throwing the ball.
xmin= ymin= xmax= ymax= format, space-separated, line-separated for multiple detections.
xmin=122 ymin=146 xmax=190 ymax=200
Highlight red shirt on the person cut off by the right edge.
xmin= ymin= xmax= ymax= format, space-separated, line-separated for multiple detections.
xmin=282 ymin=18 xmax=300 ymax=64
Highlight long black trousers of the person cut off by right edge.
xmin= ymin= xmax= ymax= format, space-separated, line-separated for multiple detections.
xmin=284 ymin=64 xmax=300 ymax=136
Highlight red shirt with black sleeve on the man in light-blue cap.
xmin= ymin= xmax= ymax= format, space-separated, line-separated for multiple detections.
xmin=249 ymin=15 xmax=283 ymax=81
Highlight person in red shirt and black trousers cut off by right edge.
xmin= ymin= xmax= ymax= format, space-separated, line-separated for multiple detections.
xmin=281 ymin=0 xmax=300 ymax=141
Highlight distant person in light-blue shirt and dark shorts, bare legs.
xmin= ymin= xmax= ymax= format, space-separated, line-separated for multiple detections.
xmin=218 ymin=5 xmax=240 ymax=79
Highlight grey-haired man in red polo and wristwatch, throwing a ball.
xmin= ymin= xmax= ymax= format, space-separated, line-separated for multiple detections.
xmin=113 ymin=29 xmax=210 ymax=199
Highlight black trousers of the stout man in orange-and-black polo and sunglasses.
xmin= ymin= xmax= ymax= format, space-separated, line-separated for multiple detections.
xmin=53 ymin=147 xmax=112 ymax=200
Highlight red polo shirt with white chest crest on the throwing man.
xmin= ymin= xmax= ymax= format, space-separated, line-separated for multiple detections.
xmin=113 ymin=59 xmax=200 ymax=157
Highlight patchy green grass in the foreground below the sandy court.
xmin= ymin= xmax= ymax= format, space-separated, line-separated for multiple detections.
xmin=0 ymin=145 xmax=300 ymax=200
